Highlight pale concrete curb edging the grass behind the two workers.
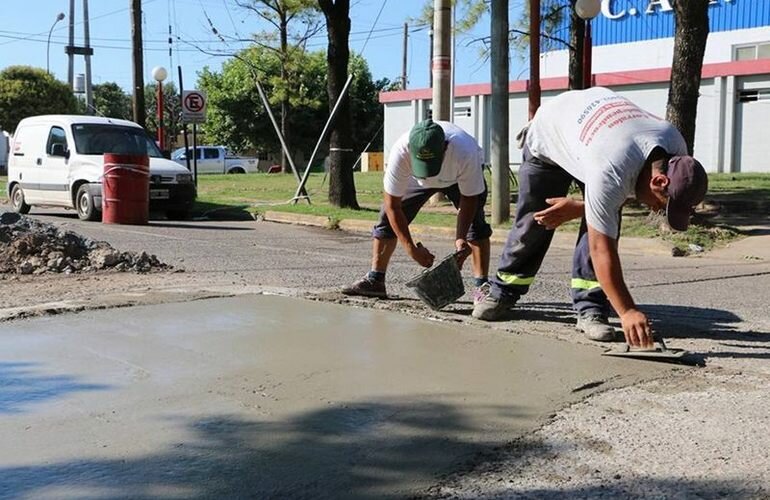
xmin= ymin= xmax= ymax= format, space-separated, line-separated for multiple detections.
xmin=262 ymin=210 xmax=673 ymax=257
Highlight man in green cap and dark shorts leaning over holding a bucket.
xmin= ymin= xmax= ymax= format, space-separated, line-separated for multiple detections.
xmin=342 ymin=120 xmax=492 ymax=303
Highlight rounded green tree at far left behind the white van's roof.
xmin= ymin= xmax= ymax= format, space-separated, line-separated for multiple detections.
xmin=0 ymin=66 xmax=78 ymax=131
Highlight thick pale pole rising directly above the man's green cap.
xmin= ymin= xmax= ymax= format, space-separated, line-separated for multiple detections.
xmin=432 ymin=0 xmax=452 ymax=121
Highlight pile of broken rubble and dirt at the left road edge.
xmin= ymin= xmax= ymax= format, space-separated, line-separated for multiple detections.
xmin=0 ymin=212 xmax=171 ymax=274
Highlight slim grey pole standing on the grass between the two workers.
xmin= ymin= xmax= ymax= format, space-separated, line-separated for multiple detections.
xmin=490 ymin=0 xmax=511 ymax=224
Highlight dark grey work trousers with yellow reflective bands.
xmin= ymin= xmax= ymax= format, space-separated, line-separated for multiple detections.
xmin=491 ymin=148 xmax=610 ymax=315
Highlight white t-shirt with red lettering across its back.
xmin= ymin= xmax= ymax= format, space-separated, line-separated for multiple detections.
xmin=526 ymin=87 xmax=687 ymax=239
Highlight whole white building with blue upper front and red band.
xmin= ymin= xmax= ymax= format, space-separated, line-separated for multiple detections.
xmin=380 ymin=0 xmax=770 ymax=172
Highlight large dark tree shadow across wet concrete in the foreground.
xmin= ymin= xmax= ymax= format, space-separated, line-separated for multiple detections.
xmin=0 ymin=398 xmax=520 ymax=499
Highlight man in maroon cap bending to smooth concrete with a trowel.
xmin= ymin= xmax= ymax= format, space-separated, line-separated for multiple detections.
xmin=473 ymin=87 xmax=708 ymax=348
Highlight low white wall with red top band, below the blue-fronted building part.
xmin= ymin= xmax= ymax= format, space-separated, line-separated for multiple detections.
xmin=381 ymin=60 xmax=770 ymax=172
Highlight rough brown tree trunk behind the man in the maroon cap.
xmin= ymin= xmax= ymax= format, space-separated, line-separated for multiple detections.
xmin=666 ymin=0 xmax=709 ymax=154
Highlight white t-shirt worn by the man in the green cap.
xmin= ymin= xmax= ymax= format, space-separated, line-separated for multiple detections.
xmin=383 ymin=121 xmax=485 ymax=198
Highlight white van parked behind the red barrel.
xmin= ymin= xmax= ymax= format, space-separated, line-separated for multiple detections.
xmin=7 ymin=115 xmax=196 ymax=220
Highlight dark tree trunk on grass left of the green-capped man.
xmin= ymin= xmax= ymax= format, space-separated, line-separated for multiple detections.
xmin=318 ymin=0 xmax=359 ymax=209
